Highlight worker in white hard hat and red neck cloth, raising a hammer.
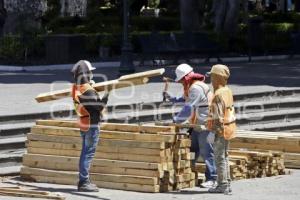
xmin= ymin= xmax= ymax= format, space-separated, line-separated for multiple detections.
xmin=163 ymin=64 xmax=216 ymax=188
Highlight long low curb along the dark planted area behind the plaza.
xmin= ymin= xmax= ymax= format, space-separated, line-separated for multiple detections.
xmin=0 ymin=55 xmax=300 ymax=72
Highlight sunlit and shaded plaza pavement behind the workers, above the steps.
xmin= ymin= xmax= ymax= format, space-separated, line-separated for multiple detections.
xmin=0 ymin=60 xmax=300 ymax=116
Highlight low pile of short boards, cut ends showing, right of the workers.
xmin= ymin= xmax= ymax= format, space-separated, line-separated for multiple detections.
xmin=196 ymin=149 xmax=285 ymax=183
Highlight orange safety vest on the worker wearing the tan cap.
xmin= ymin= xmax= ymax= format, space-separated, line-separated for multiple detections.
xmin=207 ymin=86 xmax=236 ymax=140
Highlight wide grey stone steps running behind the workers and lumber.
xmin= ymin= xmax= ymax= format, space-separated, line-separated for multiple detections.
xmin=0 ymin=90 xmax=300 ymax=175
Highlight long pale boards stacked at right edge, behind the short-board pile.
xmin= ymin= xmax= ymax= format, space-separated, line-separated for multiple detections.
xmin=230 ymin=130 xmax=300 ymax=169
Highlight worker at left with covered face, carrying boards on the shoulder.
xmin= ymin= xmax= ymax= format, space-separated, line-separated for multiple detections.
xmin=71 ymin=60 xmax=108 ymax=192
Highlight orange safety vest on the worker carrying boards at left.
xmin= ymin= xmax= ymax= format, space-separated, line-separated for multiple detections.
xmin=72 ymin=83 xmax=95 ymax=131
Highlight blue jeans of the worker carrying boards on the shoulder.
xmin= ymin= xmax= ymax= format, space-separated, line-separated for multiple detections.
xmin=79 ymin=126 xmax=100 ymax=183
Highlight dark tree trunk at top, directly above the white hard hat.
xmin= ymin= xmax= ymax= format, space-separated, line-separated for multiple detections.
xmin=180 ymin=0 xmax=202 ymax=32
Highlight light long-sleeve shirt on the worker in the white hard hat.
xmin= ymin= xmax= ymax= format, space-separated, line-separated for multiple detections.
xmin=171 ymin=82 xmax=209 ymax=125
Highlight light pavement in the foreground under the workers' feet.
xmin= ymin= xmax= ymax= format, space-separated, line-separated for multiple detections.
xmin=0 ymin=170 xmax=300 ymax=200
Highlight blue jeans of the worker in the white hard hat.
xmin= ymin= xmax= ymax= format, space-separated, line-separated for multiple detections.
xmin=191 ymin=131 xmax=217 ymax=181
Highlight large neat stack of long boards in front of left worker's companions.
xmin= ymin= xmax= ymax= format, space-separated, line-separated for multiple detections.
xmin=21 ymin=120 xmax=195 ymax=192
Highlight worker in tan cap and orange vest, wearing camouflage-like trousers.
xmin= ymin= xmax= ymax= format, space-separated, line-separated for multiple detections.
xmin=207 ymin=64 xmax=236 ymax=194
